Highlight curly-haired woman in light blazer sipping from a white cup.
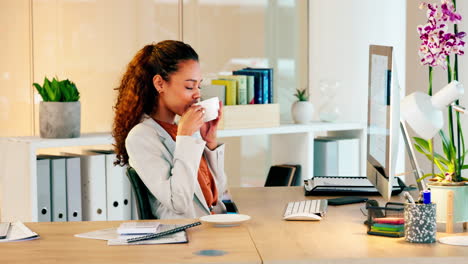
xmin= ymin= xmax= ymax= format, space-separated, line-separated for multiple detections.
xmin=113 ymin=40 xmax=226 ymax=219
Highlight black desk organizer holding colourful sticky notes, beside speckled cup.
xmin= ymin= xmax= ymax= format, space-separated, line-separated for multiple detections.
xmin=366 ymin=200 xmax=405 ymax=237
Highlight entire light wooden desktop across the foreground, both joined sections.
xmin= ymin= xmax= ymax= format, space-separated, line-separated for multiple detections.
xmin=0 ymin=187 xmax=468 ymax=264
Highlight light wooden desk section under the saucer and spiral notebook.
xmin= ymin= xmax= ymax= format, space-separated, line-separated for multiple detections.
xmin=0 ymin=219 xmax=261 ymax=264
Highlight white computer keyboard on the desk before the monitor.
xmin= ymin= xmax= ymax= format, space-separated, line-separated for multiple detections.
xmin=283 ymin=200 xmax=328 ymax=220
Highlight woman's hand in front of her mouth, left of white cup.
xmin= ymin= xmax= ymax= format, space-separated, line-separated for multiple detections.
xmin=177 ymin=105 xmax=205 ymax=136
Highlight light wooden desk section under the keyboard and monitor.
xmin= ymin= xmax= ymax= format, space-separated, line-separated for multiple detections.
xmin=231 ymin=187 xmax=468 ymax=264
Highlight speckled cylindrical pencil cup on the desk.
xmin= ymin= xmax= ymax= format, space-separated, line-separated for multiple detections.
xmin=405 ymin=203 xmax=437 ymax=243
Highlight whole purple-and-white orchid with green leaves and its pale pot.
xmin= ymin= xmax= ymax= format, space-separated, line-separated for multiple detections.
xmin=414 ymin=0 xmax=468 ymax=223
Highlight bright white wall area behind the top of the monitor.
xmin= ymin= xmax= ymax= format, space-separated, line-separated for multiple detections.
xmin=309 ymin=0 xmax=406 ymax=123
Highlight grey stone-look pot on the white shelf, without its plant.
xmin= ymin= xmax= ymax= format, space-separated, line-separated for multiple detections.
xmin=39 ymin=101 xmax=81 ymax=138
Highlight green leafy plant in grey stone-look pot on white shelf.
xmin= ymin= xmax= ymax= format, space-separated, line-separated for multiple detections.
xmin=33 ymin=77 xmax=81 ymax=138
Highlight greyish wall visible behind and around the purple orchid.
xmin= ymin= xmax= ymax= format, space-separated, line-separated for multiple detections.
xmin=406 ymin=0 xmax=468 ymax=179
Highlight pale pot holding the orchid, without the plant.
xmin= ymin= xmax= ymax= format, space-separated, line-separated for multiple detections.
xmin=429 ymin=184 xmax=468 ymax=223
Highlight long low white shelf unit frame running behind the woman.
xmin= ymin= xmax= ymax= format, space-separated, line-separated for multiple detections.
xmin=0 ymin=122 xmax=366 ymax=222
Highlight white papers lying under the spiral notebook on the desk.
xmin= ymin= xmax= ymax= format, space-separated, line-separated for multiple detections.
xmin=75 ymin=224 xmax=188 ymax=246
